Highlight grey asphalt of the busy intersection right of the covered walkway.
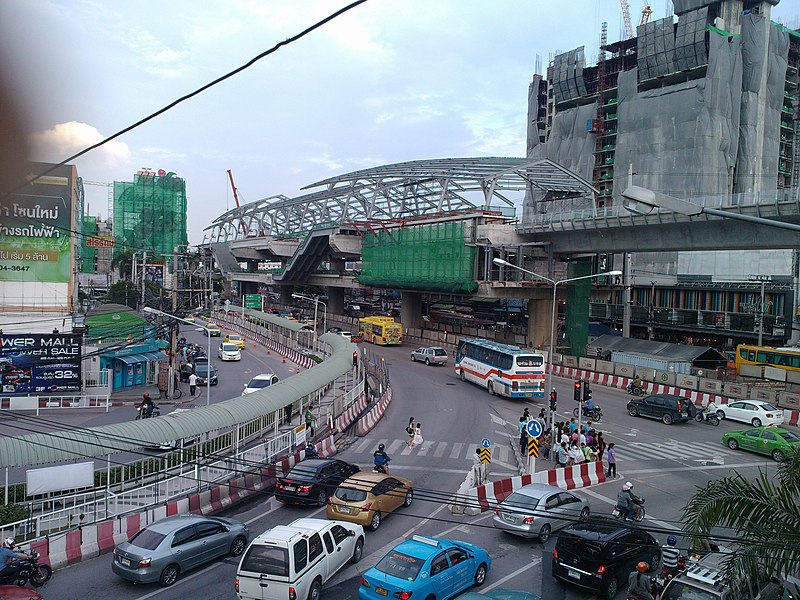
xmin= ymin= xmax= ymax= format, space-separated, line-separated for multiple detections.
xmin=26 ymin=347 xmax=788 ymax=600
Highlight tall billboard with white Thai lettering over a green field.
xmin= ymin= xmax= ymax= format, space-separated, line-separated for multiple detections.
xmin=0 ymin=164 xmax=74 ymax=309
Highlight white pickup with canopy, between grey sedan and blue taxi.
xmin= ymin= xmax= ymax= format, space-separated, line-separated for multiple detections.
xmin=236 ymin=519 xmax=364 ymax=600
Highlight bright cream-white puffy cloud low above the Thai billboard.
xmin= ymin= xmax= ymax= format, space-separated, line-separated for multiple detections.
xmin=30 ymin=121 xmax=130 ymax=168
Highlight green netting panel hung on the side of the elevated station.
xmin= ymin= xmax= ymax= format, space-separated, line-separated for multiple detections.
xmin=358 ymin=222 xmax=478 ymax=293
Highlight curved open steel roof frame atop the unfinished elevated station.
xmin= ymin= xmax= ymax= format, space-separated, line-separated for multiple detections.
xmin=206 ymin=157 xmax=597 ymax=242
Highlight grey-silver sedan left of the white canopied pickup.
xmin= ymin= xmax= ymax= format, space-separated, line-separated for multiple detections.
xmin=111 ymin=515 xmax=248 ymax=586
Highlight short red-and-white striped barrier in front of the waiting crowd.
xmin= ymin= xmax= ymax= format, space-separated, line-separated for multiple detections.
xmin=451 ymin=461 xmax=606 ymax=515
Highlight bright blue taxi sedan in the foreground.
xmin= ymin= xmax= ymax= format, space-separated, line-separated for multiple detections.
xmin=358 ymin=535 xmax=492 ymax=600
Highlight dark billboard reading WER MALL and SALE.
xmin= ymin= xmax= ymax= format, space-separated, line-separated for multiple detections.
xmin=0 ymin=333 xmax=81 ymax=394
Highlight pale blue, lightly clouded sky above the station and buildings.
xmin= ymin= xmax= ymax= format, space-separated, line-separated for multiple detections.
xmin=0 ymin=0 xmax=800 ymax=244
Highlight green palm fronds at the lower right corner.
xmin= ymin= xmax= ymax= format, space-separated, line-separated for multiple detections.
xmin=683 ymin=447 xmax=800 ymax=579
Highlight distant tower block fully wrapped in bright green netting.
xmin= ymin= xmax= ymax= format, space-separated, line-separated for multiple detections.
xmin=114 ymin=169 xmax=188 ymax=257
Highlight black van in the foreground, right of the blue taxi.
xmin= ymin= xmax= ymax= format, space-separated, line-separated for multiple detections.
xmin=552 ymin=518 xmax=661 ymax=599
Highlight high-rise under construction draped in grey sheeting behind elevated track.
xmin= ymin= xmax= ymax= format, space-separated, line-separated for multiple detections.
xmin=523 ymin=0 xmax=800 ymax=344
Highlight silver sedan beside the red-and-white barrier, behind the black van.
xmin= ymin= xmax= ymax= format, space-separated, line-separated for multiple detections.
xmin=492 ymin=483 xmax=589 ymax=544
